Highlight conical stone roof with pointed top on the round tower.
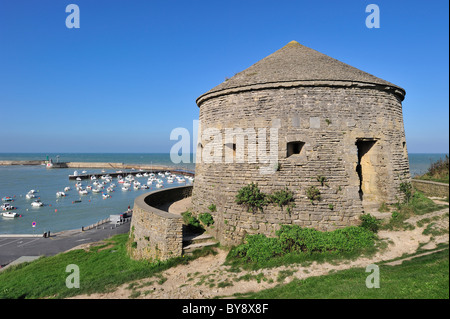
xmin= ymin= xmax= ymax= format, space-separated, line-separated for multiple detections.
xmin=197 ymin=41 xmax=405 ymax=106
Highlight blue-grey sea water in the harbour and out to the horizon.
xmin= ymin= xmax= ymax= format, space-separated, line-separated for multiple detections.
xmin=0 ymin=153 xmax=445 ymax=234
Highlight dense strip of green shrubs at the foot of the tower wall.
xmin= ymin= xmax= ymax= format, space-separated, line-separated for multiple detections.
xmin=227 ymin=225 xmax=376 ymax=268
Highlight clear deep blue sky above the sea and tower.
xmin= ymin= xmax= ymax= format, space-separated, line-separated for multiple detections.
xmin=0 ymin=0 xmax=449 ymax=153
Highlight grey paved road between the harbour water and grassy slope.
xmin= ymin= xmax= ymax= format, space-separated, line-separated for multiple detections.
xmin=0 ymin=222 xmax=131 ymax=267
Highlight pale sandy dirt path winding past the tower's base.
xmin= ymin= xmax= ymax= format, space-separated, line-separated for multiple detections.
xmin=68 ymin=208 xmax=449 ymax=299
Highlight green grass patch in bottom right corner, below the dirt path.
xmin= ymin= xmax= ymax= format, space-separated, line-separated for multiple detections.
xmin=236 ymin=248 xmax=449 ymax=299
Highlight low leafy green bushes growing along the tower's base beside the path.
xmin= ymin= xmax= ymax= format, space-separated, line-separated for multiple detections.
xmin=226 ymin=225 xmax=382 ymax=270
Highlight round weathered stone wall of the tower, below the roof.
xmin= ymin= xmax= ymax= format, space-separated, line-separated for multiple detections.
xmin=192 ymin=86 xmax=410 ymax=244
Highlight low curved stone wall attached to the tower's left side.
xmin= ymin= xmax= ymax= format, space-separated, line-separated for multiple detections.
xmin=130 ymin=186 xmax=192 ymax=260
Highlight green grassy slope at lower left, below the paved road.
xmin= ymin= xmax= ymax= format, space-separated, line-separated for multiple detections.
xmin=0 ymin=234 xmax=213 ymax=299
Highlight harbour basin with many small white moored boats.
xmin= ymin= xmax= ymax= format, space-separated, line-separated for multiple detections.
xmin=0 ymin=161 xmax=194 ymax=236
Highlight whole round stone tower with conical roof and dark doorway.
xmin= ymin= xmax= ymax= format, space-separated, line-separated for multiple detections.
xmin=192 ymin=41 xmax=410 ymax=244
